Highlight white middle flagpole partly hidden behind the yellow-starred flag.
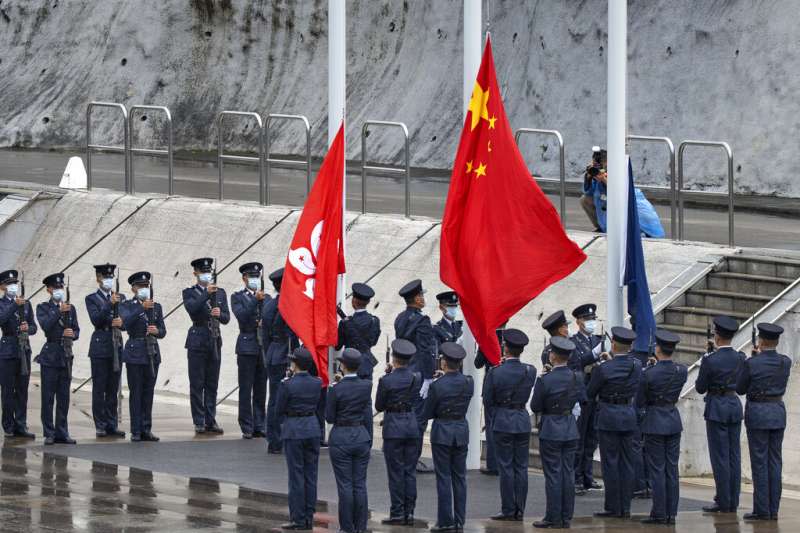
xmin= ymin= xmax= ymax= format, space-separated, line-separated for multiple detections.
xmin=463 ymin=0 xmax=483 ymax=470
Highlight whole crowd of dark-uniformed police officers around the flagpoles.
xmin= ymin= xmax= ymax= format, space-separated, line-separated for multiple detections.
xmin=0 ymin=258 xmax=792 ymax=533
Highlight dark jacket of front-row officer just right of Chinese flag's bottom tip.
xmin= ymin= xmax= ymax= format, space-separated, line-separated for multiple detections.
xmin=483 ymin=358 xmax=536 ymax=433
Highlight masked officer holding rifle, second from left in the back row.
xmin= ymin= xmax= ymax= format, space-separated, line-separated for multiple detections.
xmin=35 ymin=272 xmax=80 ymax=445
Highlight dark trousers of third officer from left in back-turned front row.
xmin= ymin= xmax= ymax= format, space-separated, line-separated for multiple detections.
xmin=383 ymin=439 xmax=420 ymax=516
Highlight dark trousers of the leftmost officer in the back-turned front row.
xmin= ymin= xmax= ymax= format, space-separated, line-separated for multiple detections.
xmin=283 ymin=437 xmax=319 ymax=524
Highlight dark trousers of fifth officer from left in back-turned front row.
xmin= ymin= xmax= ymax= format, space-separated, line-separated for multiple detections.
xmin=494 ymin=431 xmax=531 ymax=516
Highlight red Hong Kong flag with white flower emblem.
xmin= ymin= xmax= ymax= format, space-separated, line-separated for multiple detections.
xmin=278 ymin=124 xmax=345 ymax=385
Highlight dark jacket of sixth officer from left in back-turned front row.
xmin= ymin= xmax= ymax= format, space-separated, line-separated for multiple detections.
xmin=531 ymin=366 xmax=586 ymax=441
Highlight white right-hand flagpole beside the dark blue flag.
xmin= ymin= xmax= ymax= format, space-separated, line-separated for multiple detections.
xmin=606 ymin=0 xmax=628 ymax=326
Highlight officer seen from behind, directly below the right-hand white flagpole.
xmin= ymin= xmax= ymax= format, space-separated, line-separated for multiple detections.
xmin=586 ymin=327 xmax=642 ymax=518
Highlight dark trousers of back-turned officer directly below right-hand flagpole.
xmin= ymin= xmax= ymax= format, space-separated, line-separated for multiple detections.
xmin=598 ymin=430 xmax=635 ymax=515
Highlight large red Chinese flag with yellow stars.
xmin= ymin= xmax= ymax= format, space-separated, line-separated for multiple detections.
xmin=440 ymin=39 xmax=586 ymax=364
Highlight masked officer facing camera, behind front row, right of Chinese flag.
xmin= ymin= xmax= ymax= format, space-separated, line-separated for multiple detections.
xmin=570 ymin=303 xmax=603 ymax=494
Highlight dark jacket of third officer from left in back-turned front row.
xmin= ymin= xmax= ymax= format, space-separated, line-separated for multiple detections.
xmin=375 ymin=367 xmax=422 ymax=439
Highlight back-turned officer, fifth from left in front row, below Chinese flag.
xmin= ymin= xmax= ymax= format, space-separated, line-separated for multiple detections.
xmin=483 ymin=329 xmax=536 ymax=522
